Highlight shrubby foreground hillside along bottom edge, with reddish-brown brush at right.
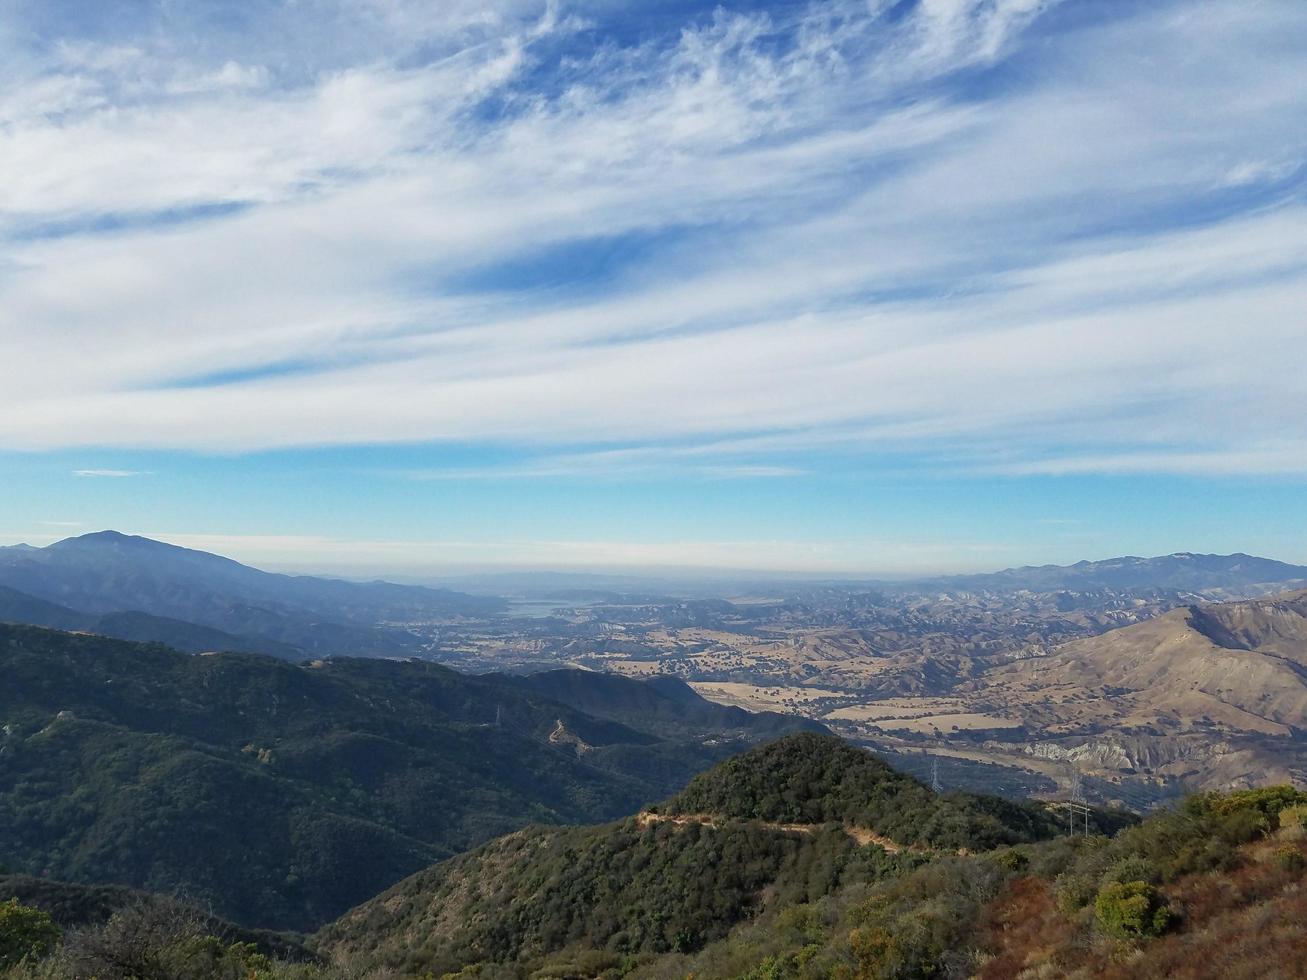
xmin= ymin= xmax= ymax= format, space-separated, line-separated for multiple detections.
xmin=0 ymin=736 xmax=1307 ymax=980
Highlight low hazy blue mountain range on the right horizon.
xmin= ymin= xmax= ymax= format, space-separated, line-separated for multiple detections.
xmin=918 ymin=551 xmax=1307 ymax=598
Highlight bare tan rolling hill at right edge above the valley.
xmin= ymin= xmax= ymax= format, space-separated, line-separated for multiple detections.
xmin=976 ymin=592 xmax=1307 ymax=789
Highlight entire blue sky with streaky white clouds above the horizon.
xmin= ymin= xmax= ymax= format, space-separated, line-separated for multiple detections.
xmin=0 ymin=0 xmax=1307 ymax=575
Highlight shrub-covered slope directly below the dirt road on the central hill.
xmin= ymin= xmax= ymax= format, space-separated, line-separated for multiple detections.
xmin=320 ymin=819 xmax=855 ymax=976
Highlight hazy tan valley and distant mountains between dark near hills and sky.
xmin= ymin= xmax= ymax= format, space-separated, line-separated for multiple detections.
xmin=0 ymin=532 xmax=1307 ymax=810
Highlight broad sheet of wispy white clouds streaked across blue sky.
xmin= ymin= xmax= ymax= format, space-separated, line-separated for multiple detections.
xmin=0 ymin=0 xmax=1307 ymax=477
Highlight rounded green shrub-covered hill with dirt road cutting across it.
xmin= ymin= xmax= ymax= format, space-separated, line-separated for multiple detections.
xmin=313 ymin=733 xmax=1057 ymax=975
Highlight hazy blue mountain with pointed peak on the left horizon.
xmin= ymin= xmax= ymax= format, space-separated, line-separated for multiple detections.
xmin=0 ymin=531 xmax=505 ymax=659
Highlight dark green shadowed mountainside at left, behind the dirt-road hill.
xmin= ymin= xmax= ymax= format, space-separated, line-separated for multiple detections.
xmin=0 ymin=626 xmax=810 ymax=929
